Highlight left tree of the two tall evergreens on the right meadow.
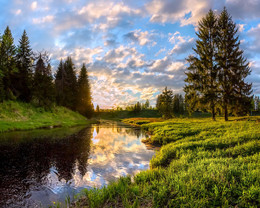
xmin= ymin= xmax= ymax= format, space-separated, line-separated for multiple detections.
xmin=184 ymin=10 xmax=218 ymax=120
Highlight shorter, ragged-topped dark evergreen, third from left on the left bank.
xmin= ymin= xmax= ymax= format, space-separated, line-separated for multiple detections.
xmin=33 ymin=53 xmax=55 ymax=108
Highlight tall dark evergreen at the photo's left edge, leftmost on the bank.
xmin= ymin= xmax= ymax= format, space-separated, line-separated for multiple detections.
xmin=0 ymin=26 xmax=17 ymax=100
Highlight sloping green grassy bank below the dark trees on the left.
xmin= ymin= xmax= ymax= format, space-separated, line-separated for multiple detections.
xmin=0 ymin=101 xmax=93 ymax=132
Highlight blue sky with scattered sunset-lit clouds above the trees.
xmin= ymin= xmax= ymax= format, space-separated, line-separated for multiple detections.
xmin=0 ymin=0 xmax=260 ymax=108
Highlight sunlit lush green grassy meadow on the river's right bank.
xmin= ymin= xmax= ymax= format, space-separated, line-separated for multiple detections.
xmin=73 ymin=117 xmax=260 ymax=207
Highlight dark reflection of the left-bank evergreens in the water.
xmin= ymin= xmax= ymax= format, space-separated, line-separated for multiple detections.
xmin=0 ymin=128 xmax=91 ymax=207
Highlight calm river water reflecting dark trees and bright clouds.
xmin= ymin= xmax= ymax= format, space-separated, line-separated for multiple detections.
xmin=0 ymin=122 xmax=154 ymax=207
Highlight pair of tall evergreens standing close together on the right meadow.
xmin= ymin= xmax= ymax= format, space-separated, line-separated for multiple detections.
xmin=184 ymin=8 xmax=252 ymax=121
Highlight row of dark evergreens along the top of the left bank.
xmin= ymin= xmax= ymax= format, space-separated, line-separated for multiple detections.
xmin=0 ymin=26 xmax=94 ymax=117
